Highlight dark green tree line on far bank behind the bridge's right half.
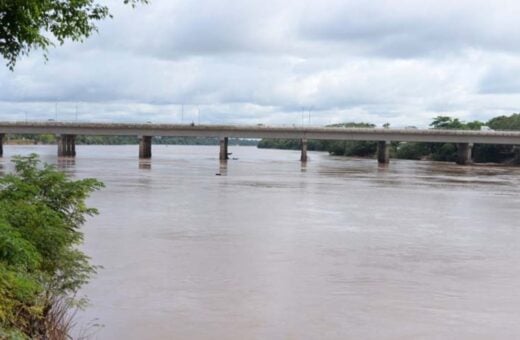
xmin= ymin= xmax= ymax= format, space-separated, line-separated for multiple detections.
xmin=258 ymin=113 xmax=520 ymax=163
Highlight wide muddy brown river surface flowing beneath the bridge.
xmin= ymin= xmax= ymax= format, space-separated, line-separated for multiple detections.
xmin=0 ymin=146 xmax=520 ymax=339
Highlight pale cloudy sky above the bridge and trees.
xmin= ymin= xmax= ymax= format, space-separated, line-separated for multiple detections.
xmin=0 ymin=0 xmax=520 ymax=127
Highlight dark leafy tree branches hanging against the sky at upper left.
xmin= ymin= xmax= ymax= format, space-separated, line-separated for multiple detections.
xmin=0 ymin=0 xmax=148 ymax=70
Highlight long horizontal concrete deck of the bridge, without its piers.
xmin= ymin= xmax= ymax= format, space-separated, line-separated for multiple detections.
xmin=0 ymin=122 xmax=520 ymax=145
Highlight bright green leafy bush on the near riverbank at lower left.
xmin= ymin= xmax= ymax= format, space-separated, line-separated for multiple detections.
xmin=0 ymin=154 xmax=102 ymax=338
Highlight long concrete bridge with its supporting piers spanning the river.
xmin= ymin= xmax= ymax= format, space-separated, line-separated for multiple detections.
xmin=0 ymin=122 xmax=520 ymax=164
